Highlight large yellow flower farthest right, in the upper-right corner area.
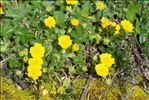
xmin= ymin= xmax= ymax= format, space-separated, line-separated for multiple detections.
xmin=121 ymin=19 xmax=133 ymax=32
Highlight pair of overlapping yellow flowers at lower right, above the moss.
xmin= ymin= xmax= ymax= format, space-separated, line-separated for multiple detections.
xmin=95 ymin=53 xmax=115 ymax=77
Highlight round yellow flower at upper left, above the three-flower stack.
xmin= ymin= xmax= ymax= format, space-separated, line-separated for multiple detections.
xmin=44 ymin=16 xmax=56 ymax=28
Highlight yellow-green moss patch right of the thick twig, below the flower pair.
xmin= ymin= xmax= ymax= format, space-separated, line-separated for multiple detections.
xmin=86 ymin=80 xmax=121 ymax=100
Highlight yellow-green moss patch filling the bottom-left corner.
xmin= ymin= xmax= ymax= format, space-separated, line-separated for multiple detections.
xmin=0 ymin=77 xmax=31 ymax=100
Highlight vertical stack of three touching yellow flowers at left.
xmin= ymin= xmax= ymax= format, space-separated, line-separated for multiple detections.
xmin=27 ymin=43 xmax=45 ymax=80
